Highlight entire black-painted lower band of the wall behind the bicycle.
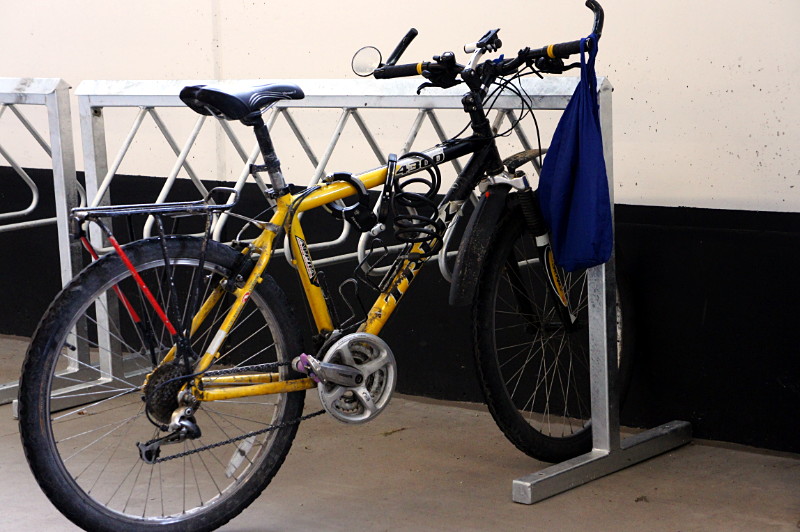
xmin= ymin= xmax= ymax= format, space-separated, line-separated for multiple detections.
xmin=0 ymin=167 xmax=800 ymax=452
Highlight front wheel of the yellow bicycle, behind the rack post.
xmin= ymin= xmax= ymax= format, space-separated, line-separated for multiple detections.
xmin=473 ymin=201 xmax=632 ymax=462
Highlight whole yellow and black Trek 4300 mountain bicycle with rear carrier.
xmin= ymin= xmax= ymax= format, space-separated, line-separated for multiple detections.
xmin=14 ymin=0 xmax=625 ymax=531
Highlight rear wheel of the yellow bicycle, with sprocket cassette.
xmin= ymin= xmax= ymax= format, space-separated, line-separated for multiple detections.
xmin=19 ymin=237 xmax=304 ymax=531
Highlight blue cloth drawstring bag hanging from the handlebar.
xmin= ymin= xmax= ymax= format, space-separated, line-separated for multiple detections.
xmin=538 ymin=34 xmax=614 ymax=271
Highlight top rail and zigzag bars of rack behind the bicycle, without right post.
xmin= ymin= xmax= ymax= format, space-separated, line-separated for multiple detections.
xmin=76 ymin=78 xmax=577 ymax=265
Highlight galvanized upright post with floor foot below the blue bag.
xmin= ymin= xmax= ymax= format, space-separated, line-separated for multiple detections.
xmin=512 ymin=78 xmax=692 ymax=504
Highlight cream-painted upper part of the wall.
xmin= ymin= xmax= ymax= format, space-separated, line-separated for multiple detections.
xmin=0 ymin=0 xmax=800 ymax=211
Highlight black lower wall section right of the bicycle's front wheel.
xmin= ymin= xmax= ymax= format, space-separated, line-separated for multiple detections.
xmin=616 ymin=205 xmax=800 ymax=452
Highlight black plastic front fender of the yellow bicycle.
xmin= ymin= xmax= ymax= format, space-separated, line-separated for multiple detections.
xmin=450 ymin=185 xmax=511 ymax=306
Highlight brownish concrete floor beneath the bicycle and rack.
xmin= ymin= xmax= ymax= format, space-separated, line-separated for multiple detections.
xmin=0 ymin=334 xmax=800 ymax=532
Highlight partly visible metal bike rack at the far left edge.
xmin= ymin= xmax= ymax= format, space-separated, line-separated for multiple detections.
xmin=0 ymin=78 xmax=82 ymax=404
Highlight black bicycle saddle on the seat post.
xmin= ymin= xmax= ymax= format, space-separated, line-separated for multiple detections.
xmin=180 ymin=83 xmax=305 ymax=120
